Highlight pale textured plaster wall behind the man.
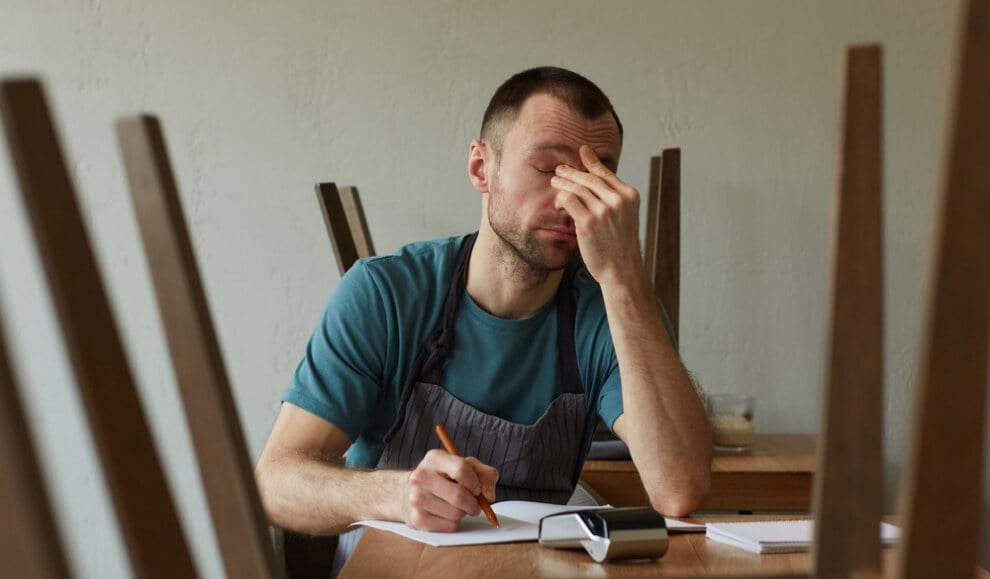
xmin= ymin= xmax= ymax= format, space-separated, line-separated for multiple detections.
xmin=0 ymin=0 xmax=990 ymax=577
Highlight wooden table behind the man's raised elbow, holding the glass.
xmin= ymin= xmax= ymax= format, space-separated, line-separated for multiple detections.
xmin=581 ymin=434 xmax=816 ymax=512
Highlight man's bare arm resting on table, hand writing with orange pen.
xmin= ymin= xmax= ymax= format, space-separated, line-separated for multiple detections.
xmin=255 ymin=403 xmax=498 ymax=535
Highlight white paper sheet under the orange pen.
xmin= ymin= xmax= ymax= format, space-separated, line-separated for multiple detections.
xmin=351 ymin=501 xmax=705 ymax=547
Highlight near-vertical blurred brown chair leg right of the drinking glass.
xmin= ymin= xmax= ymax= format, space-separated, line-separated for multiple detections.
xmin=812 ymin=45 xmax=883 ymax=578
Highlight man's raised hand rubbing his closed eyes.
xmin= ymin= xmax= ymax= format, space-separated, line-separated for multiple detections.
xmin=550 ymin=145 xmax=642 ymax=285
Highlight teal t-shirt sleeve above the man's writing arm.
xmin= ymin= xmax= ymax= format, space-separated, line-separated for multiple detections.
xmin=282 ymin=262 xmax=388 ymax=440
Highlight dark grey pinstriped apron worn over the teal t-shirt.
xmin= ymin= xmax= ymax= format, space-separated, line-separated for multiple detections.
xmin=334 ymin=234 xmax=589 ymax=570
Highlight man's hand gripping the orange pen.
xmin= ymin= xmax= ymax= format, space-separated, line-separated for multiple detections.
xmin=402 ymin=449 xmax=498 ymax=532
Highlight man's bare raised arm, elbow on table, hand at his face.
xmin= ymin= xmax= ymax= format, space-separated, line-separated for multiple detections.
xmin=552 ymin=146 xmax=712 ymax=516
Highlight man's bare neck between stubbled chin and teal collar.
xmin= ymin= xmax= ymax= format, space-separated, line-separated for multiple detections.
xmin=467 ymin=227 xmax=563 ymax=320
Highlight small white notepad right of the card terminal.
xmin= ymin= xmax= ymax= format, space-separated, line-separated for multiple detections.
xmin=705 ymin=520 xmax=901 ymax=553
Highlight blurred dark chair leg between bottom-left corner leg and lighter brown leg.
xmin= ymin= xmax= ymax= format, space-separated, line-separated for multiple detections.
xmin=0 ymin=80 xmax=197 ymax=579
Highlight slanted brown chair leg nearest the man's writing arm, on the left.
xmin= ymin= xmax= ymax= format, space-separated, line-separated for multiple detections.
xmin=117 ymin=116 xmax=281 ymax=579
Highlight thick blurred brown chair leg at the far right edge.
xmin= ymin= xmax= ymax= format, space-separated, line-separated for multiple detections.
xmin=898 ymin=0 xmax=990 ymax=579
